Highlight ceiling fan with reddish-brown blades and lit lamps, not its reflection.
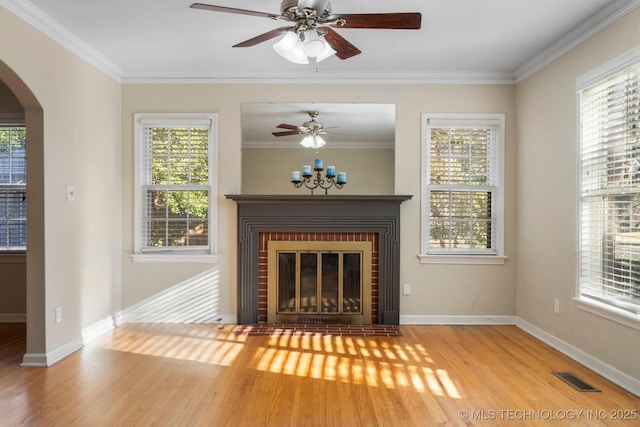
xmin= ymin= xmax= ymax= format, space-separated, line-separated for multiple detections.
xmin=190 ymin=0 xmax=422 ymax=64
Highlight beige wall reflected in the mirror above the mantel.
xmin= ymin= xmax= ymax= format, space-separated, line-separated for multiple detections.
xmin=242 ymin=148 xmax=395 ymax=194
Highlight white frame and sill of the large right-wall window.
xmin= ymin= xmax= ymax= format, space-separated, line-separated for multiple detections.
xmin=573 ymin=48 xmax=640 ymax=329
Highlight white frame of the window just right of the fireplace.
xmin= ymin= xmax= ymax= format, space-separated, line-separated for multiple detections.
xmin=418 ymin=113 xmax=507 ymax=264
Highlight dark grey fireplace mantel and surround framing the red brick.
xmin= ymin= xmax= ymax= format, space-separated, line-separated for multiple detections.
xmin=226 ymin=194 xmax=412 ymax=325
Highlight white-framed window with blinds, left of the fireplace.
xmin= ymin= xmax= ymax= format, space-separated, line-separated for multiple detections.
xmin=134 ymin=114 xmax=217 ymax=262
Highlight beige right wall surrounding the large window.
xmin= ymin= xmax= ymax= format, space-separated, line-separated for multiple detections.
xmin=516 ymin=9 xmax=640 ymax=378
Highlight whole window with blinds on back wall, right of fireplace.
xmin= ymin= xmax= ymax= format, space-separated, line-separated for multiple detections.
xmin=420 ymin=114 xmax=505 ymax=264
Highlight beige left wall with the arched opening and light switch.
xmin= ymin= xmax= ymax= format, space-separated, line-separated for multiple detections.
xmin=0 ymin=8 xmax=121 ymax=357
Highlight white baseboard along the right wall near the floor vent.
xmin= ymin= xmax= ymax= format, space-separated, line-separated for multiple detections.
xmin=516 ymin=318 xmax=640 ymax=396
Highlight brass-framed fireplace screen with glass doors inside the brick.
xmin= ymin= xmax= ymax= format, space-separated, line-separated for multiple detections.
xmin=268 ymin=241 xmax=371 ymax=323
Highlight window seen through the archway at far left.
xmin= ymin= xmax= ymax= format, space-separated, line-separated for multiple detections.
xmin=0 ymin=124 xmax=27 ymax=253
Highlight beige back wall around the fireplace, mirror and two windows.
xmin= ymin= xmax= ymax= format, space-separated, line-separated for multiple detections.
xmin=122 ymin=84 xmax=517 ymax=316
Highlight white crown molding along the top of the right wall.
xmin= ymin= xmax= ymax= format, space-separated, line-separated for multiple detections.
xmin=514 ymin=0 xmax=640 ymax=83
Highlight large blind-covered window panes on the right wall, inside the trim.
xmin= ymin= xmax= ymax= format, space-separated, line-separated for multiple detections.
xmin=578 ymin=55 xmax=640 ymax=315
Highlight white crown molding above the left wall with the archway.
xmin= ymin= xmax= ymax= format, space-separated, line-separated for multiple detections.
xmin=0 ymin=0 xmax=123 ymax=82
